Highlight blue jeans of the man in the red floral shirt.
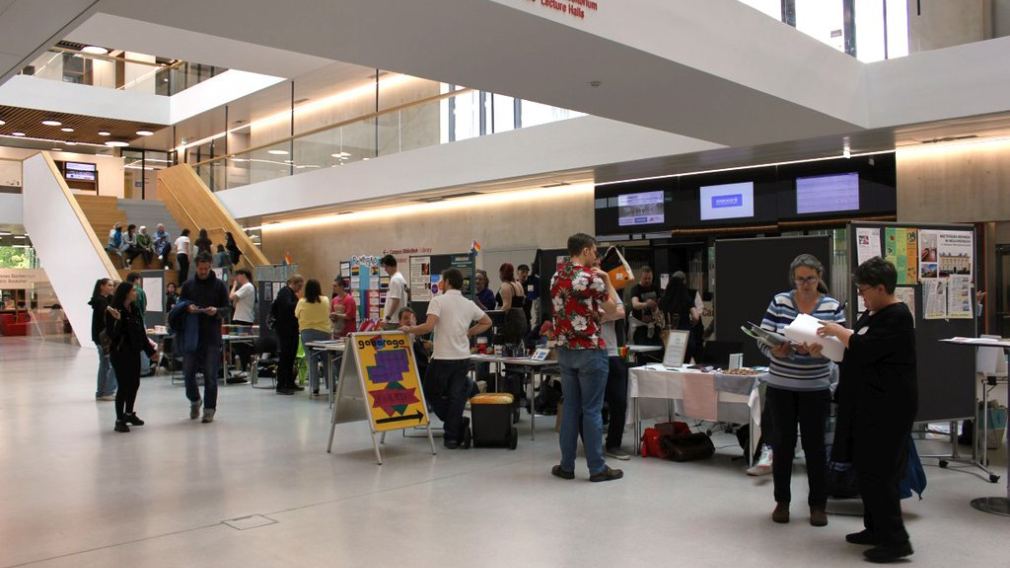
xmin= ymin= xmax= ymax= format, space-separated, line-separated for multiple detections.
xmin=558 ymin=348 xmax=610 ymax=474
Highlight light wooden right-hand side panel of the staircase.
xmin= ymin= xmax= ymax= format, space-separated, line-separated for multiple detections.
xmin=158 ymin=164 xmax=271 ymax=270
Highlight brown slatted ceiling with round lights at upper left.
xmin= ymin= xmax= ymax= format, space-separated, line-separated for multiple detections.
xmin=0 ymin=105 xmax=164 ymax=144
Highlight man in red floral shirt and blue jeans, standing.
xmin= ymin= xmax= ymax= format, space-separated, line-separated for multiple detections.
xmin=550 ymin=232 xmax=624 ymax=481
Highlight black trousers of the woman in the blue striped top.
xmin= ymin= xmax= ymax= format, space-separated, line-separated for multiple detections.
xmin=766 ymin=386 xmax=831 ymax=507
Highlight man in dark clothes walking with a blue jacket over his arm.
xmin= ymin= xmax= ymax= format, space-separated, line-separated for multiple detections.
xmin=179 ymin=253 xmax=231 ymax=423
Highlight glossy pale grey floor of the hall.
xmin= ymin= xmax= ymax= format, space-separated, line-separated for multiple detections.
xmin=0 ymin=338 xmax=1010 ymax=568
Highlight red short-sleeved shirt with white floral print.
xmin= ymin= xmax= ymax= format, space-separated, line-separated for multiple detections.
xmin=550 ymin=261 xmax=607 ymax=349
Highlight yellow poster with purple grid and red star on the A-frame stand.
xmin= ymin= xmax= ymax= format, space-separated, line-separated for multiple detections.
xmin=350 ymin=332 xmax=428 ymax=432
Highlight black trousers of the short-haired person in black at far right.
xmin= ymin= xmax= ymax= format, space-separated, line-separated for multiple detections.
xmin=856 ymin=420 xmax=912 ymax=545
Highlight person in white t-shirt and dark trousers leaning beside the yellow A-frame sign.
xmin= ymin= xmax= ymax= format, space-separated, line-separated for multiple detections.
xmin=400 ymin=268 xmax=491 ymax=450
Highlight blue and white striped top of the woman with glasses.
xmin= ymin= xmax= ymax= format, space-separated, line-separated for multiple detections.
xmin=761 ymin=291 xmax=845 ymax=391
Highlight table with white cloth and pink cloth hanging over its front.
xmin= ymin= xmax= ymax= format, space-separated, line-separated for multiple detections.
xmin=628 ymin=364 xmax=767 ymax=457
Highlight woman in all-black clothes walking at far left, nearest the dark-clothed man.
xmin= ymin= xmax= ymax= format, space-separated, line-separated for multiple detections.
xmin=105 ymin=282 xmax=155 ymax=432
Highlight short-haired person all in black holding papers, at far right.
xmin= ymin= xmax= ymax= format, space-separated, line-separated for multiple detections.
xmin=818 ymin=257 xmax=918 ymax=562
